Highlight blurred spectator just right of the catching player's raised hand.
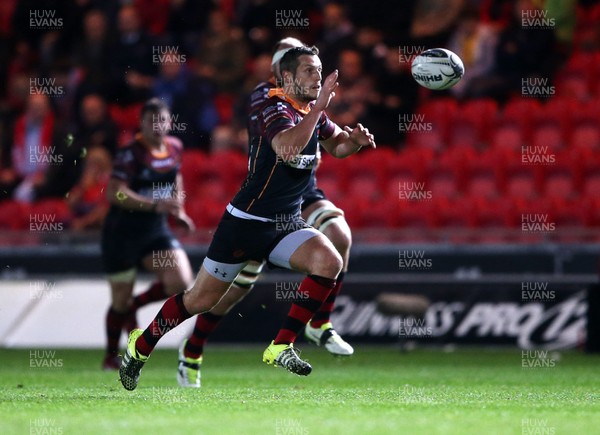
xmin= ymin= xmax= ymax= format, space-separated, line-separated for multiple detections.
xmin=327 ymin=49 xmax=373 ymax=129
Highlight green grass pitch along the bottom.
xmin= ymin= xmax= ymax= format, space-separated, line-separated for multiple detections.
xmin=0 ymin=344 xmax=600 ymax=435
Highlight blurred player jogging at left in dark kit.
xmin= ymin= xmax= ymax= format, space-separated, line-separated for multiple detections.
xmin=102 ymin=99 xmax=194 ymax=370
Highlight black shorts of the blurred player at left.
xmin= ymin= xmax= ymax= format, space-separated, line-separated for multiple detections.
xmin=101 ymin=216 xmax=181 ymax=274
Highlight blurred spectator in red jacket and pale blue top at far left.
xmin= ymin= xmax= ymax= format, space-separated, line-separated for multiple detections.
xmin=0 ymin=93 xmax=56 ymax=202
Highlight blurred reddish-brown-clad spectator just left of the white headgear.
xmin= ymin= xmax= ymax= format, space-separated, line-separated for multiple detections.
xmin=196 ymin=10 xmax=248 ymax=94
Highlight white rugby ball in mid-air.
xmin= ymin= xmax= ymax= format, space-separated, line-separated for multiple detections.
xmin=410 ymin=48 xmax=465 ymax=91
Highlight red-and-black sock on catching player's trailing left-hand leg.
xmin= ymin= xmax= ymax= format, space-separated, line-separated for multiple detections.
xmin=135 ymin=293 xmax=191 ymax=356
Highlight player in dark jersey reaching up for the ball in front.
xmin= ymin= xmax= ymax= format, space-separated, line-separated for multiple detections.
xmin=119 ymin=47 xmax=375 ymax=390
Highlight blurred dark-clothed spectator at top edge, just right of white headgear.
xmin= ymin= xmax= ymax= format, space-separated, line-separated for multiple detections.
xmin=317 ymin=3 xmax=354 ymax=71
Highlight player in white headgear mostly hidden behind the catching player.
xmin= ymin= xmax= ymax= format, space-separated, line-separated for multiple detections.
xmin=177 ymin=38 xmax=354 ymax=388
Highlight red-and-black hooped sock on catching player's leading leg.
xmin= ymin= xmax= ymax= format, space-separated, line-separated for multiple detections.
xmin=273 ymin=275 xmax=335 ymax=344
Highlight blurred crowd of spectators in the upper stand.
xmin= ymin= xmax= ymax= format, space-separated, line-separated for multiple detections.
xmin=0 ymin=0 xmax=600 ymax=230
